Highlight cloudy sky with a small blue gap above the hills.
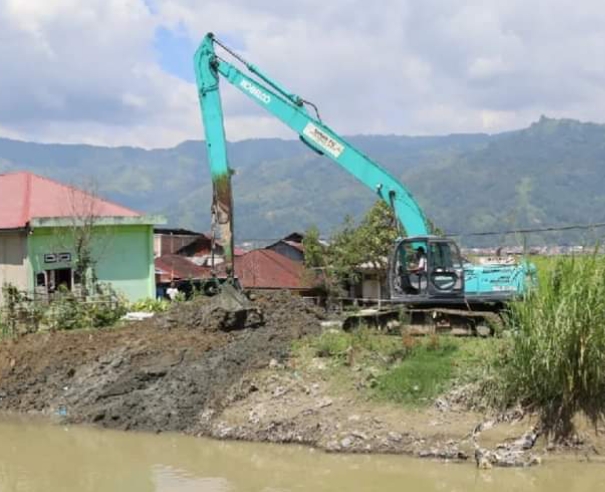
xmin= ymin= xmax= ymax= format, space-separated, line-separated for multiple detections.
xmin=0 ymin=0 xmax=605 ymax=148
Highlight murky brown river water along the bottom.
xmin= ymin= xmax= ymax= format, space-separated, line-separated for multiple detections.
xmin=0 ymin=418 xmax=605 ymax=492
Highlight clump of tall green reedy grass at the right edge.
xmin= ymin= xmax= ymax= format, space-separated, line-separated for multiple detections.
xmin=500 ymin=254 xmax=605 ymax=439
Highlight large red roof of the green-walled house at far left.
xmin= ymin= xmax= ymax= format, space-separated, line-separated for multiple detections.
xmin=0 ymin=172 xmax=140 ymax=229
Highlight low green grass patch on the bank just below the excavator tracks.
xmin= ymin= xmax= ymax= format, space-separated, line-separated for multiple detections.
xmin=294 ymin=328 xmax=490 ymax=407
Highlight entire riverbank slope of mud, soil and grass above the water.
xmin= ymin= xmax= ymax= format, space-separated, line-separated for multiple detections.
xmin=0 ymin=293 xmax=594 ymax=465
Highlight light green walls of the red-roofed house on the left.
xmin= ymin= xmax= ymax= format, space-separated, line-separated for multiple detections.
xmin=28 ymin=225 xmax=155 ymax=301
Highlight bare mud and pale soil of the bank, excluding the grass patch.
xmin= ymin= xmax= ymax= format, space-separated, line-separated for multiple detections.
xmin=0 ymin=292 xmax=556 ymax=467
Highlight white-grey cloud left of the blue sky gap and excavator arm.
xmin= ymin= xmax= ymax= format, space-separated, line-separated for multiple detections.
xmin=0 ymin=0 xmax=199 ymax=146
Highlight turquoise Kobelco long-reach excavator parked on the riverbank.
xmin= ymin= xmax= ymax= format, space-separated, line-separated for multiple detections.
xmin=194 ymin=33 xmax=535 ymax=332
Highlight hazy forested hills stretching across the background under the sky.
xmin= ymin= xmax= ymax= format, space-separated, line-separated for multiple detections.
xmin=0 ymin=117 xmax=605 ymax=246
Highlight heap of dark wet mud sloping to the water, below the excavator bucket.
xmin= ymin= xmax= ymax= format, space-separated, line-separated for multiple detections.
xmin=0 ymin=292 xmax=320 ymax=432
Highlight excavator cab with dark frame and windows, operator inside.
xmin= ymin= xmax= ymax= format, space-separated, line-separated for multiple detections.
xmin=389 ymin=236 xmax=464 ymax=304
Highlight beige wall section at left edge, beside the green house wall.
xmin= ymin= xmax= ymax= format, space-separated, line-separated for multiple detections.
xmin=0 ymin=231 xmax=29 ymax=302
